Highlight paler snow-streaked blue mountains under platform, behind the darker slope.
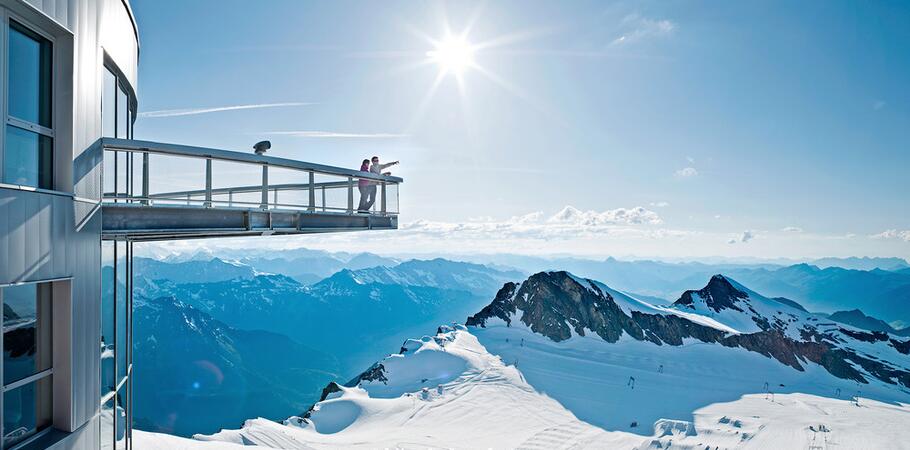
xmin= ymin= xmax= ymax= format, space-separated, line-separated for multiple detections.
xmin=135 ymin=259 xmax=520 ymax=374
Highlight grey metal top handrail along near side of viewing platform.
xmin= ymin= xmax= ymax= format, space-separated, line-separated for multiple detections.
xmin=101 ymin=138 xmax=404 ymax=184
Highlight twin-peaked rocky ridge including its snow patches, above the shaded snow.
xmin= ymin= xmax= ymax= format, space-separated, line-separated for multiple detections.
xmin=467 ymin=272 xmax=910 ymax=387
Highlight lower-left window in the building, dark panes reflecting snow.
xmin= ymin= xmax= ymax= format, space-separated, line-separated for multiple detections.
xmin=2 ymin=283 xmax=53 ymax=448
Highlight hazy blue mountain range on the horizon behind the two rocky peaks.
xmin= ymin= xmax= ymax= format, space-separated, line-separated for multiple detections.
xmin=456 ymin=255 xmax=910 ymax=323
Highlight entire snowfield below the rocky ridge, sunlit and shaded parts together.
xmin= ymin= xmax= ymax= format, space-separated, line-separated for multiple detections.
xmin=134 ymin=321 xmax=910 ymax=449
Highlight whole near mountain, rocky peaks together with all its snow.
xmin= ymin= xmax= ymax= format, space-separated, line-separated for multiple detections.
xmin=137 ymin=272 xmax=910 ymax=449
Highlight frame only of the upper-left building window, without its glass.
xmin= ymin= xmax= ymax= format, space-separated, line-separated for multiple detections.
xmin=0 ymin=8 xmax=60 ymax=191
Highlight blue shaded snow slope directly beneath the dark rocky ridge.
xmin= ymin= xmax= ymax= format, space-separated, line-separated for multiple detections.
xmin=471 ymin=314 xmax=910 ymax=438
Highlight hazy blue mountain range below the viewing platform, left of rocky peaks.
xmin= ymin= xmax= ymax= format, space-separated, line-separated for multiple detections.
xmin=132 ymin=258 xmax=520 ymax=436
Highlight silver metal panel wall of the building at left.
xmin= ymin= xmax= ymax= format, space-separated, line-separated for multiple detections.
xmin=0 ymin=0 xmax=139 ymax=448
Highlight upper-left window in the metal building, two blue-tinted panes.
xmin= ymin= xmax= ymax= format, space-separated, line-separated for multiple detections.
xmin=3 ymin=20 xmax=54 ymax=189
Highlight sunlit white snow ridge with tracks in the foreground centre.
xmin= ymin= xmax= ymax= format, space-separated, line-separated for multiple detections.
xmin=189 ymin=327 xmax=624 ymax=448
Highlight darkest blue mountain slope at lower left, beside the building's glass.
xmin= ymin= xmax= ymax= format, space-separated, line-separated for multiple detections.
xmin=133 ymin=297 xmax=338 ymax=436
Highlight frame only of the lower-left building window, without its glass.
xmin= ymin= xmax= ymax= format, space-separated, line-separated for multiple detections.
xmin=0 ymin=277 xmax=56 ymax=450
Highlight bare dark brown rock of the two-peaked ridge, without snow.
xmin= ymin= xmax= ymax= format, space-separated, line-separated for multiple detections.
xmin=466 ymin=272 xmax=910 ymax=386
